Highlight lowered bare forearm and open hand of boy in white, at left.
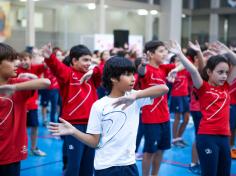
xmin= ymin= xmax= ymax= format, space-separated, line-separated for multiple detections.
xmin=48 ymin=118 xmax=100 ymax=148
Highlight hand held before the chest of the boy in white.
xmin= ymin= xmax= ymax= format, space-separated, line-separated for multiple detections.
xmin=112 ymin=94 xmax=136 ymax=110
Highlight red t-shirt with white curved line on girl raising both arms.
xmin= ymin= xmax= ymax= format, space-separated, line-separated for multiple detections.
xmin=197 ymin=81 xmax=230 ymax=135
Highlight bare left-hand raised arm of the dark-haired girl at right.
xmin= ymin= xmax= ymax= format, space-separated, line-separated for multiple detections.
xmin=166 ymin=41 xmax=203 ymax=89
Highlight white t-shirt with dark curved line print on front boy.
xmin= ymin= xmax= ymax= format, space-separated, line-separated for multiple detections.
xmin=87 ymin=91 xmax=153 ymax=170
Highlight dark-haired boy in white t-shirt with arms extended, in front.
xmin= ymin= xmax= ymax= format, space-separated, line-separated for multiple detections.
xmin=49 ymin=56 xmax=168 ymax=176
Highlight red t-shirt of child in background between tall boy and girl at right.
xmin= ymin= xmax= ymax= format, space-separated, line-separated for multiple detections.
xmin=171 ymin=69 xmax=189 ymax=96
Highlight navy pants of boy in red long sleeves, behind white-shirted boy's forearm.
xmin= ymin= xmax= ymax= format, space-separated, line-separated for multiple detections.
xmin=64 ymin=125 xmax=95 ymax=176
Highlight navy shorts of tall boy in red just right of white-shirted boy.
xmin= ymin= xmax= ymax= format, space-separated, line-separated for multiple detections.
xmin=143 ymin=121 xmax=171 ymax=153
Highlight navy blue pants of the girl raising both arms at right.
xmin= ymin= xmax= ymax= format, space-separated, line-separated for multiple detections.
xmin=197 ymin=134 xmax=231 ymax=176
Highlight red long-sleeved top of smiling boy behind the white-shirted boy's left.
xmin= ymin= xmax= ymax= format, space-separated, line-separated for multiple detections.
xmin=45 ymin=54 xmax=101 ymax=124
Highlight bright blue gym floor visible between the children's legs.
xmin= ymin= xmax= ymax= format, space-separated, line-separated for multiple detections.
xmin=21 ymin=115 xmax=236 ymax=176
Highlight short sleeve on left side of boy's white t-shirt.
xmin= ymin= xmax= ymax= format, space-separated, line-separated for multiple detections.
xmin=87 ymin=103 xmax=102 ymax=134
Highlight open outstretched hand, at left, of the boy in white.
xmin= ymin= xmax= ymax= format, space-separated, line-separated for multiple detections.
xmin=47 ymin=118 xmax=76 ymax=136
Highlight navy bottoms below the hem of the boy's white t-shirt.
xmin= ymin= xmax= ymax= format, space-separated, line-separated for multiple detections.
xmin=95 ymin=164 xmax=139 ymax=176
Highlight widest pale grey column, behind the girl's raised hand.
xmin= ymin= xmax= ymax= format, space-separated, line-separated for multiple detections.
xmin=159 ymin=0 xmax=182 ymax=43
